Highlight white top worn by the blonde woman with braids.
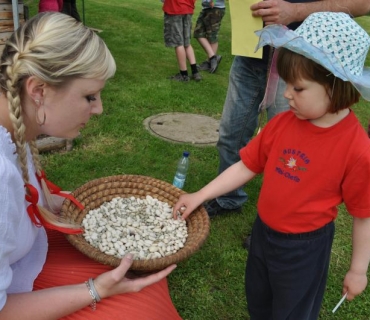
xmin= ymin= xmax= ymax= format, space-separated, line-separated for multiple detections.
xmin=0 ymin=126 xmax=47 ymax=310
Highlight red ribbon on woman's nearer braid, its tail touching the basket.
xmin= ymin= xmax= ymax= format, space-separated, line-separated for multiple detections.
xmin=25 ymin=183 xmax=83 ymax=234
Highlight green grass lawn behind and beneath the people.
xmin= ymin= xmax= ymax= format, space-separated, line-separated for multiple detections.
xmin=26 ymin=0 xmax=370 ymax=320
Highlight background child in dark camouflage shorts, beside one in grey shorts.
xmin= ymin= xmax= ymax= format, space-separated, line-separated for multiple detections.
xmin=194 ymin=0 xmax=225 ymax=73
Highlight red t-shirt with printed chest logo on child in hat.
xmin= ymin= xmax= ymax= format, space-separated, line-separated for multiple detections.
xmin=240 ymin=111 xmax=370 ymax=233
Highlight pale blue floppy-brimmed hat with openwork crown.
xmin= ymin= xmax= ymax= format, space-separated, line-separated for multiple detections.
xmin=255 ymin=12 xmax=370 ymax=101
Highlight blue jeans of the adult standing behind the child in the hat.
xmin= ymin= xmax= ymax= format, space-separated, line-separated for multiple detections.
xmin=216 ymin=56 xmax=288 ymax=209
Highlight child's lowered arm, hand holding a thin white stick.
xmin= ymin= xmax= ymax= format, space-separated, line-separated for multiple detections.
xmin=342 ymin=217 xmax=370 ymax=300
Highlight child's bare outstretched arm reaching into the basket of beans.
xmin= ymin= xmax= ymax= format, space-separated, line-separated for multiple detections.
xmin=173 ymin=161 xmax=256 ymax=219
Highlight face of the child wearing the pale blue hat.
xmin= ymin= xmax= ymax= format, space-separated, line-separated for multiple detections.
xmin=284 ymin=79 xmax=330 ymax=123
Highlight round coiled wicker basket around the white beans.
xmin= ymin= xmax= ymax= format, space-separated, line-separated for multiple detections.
xmin=61 ymin=175 xmax=210 ymax=272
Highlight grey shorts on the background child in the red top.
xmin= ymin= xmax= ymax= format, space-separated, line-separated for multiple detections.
xmin=164 ymin=13 xmax=193 ymax=47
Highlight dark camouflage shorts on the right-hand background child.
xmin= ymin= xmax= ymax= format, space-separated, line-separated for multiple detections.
xmin=194 ymin=8 xmax=225 ymax=43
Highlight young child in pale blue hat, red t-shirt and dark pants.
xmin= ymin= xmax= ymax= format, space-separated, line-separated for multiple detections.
xmin=174 ymin=12 xmax=370 ymax=320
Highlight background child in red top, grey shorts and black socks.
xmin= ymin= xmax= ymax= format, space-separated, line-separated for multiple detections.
xmin=163 ymin=0 xmax=202 ymax=82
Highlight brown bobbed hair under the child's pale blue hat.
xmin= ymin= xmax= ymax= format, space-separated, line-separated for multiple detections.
xmin=277 ymin=48 xmax=360 ymax=113
